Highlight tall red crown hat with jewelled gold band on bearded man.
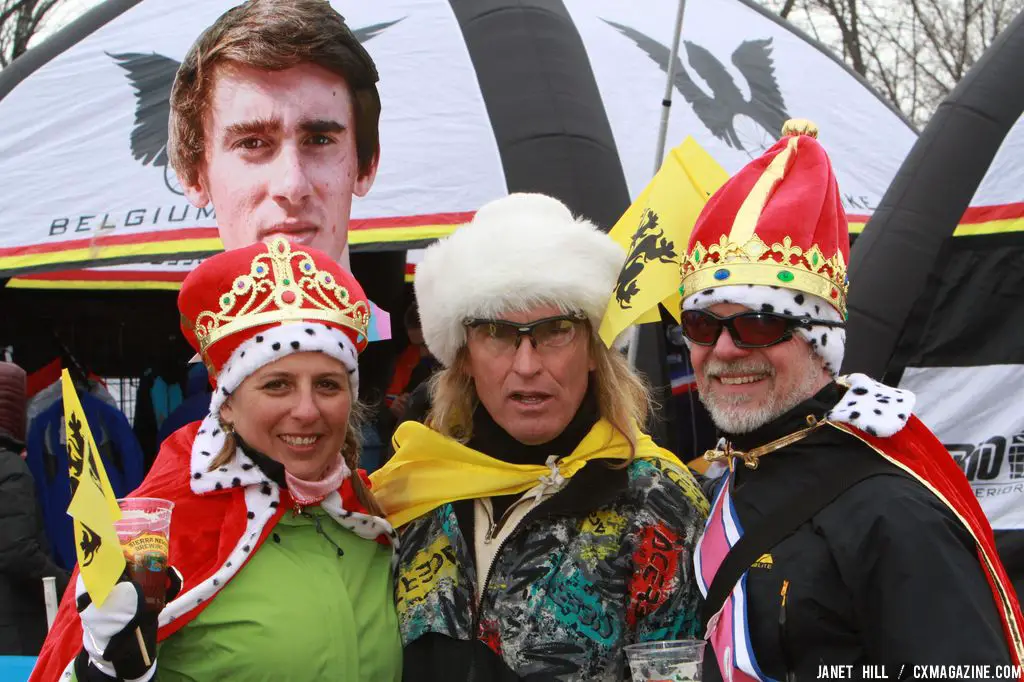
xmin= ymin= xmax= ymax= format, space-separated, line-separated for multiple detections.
xmin=680 ymin=119 xmax=850 ymax=317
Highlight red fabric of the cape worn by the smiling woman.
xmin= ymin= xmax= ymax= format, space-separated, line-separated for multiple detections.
xmin=35 ymin=422 xmax=386 ymax=682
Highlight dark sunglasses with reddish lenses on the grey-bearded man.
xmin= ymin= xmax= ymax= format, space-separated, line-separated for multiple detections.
xmin=682 ymin=310 xmax=846 ymax=348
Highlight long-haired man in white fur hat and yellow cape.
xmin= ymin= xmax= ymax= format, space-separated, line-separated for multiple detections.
xmin=373 ymin=195 xmax=707 ymax=682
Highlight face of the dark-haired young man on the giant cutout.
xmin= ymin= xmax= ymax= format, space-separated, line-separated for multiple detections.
xmin=185 ymin=59 xmax=377 ymax=260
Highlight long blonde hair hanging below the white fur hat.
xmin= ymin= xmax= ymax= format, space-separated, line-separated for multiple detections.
xmin=426 ymin=324 xmax=653 ymax=460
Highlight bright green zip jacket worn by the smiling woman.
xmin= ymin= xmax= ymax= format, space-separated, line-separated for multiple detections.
xmin=72 ymin=507 xmax=401 ymax=682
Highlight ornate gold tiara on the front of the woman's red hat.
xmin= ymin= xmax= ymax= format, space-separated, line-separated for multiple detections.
xmin=182 ymin=238 xmax=370 ymax=355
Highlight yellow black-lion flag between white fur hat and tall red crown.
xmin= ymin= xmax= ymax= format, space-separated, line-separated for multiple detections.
xmin=600 ymin=137 xmax=729 ymax=346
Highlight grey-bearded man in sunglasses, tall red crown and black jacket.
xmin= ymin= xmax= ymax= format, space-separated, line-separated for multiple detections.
xmin=681 ymin=121 xmax=1022 ymax=680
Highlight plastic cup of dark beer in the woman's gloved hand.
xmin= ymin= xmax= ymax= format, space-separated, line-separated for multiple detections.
xmin=114 ymin=498 xmax=174 ymax=611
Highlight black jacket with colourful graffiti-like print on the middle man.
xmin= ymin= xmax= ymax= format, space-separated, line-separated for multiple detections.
xmin=395 ymin=448 xmax=708 ymax=682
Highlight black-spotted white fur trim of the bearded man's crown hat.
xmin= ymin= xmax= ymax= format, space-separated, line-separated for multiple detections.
xmin=683 ymin=285 xmax=846 ymax=377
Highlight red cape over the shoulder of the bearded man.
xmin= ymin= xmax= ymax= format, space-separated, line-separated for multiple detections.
xmin=833 ymin=416 xmax=1024 ymax=667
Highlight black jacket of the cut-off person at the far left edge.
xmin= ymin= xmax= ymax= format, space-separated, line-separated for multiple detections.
xmin=0 ymin=435 xmax=69 ymax=655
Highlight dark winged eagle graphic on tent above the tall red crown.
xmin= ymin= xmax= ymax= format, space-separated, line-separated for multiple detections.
xmin=603 ymin=19 xmax=790 ymax=156
